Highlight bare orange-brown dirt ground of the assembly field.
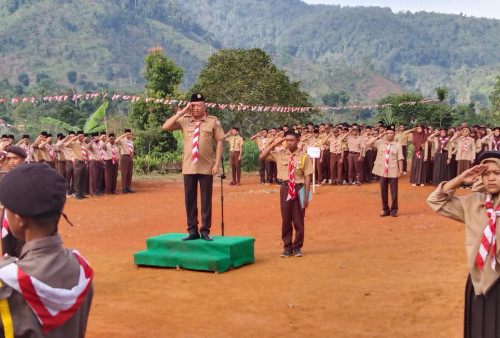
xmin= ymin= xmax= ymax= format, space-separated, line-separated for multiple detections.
xmin=55 ymin=175 xmax=467 ymax=338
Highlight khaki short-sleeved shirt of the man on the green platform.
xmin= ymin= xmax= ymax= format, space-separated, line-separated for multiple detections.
xmin=172 ymin=116 xmax=226 ymax=175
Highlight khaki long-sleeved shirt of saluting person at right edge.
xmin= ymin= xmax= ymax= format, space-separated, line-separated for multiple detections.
xmin=427 ymin=182 xmax=500 ymax=295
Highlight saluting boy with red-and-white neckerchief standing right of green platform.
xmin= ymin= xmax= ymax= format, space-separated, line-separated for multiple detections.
xmin=259 ymin=130 xmax=313 ymax=257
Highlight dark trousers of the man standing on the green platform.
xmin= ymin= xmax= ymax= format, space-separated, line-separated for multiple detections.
xmin=184 ymin=174 xmax=214 ymax=235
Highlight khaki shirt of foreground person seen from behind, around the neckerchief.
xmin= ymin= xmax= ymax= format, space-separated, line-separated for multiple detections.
xmin=0 ymin=235 xmax=94 ymax=338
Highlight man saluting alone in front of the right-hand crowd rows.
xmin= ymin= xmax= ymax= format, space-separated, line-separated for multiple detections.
xmin=367 ymin=125 xmax=403 ymax=217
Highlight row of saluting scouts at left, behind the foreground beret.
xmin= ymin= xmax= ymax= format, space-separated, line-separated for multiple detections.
xmin=0 ymin=129 xmax=135 ymax=199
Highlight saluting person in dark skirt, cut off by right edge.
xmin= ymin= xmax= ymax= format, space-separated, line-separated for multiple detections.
xmin=427 ymin=151 xmax=500 ymax=337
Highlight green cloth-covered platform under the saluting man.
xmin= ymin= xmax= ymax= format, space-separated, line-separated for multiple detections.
xmin=134 ymin=233 xmax=255 ymax=272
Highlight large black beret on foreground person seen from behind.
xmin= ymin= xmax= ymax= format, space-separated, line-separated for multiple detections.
xmin=0 ymin=163 xmax=66 ymax=218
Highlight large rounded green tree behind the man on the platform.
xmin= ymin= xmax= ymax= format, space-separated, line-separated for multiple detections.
xmin=191 ymin=49 xmax=310 ymax=133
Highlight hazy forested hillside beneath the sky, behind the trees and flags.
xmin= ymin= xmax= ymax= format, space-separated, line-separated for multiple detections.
xmin=0 ymin=0 xmax=500 ymax=106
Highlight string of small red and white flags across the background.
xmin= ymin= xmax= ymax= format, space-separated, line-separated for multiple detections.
xmin=0 ymin=93 xmax=439 ymax=113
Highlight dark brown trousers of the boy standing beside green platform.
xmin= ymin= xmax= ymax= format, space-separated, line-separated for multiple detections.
xmin=280 ymin=182 xmax=304 ymax=249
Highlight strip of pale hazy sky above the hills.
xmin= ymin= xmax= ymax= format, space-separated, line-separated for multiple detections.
xmin=303 ymin=0 xmax=500 ymax=19
